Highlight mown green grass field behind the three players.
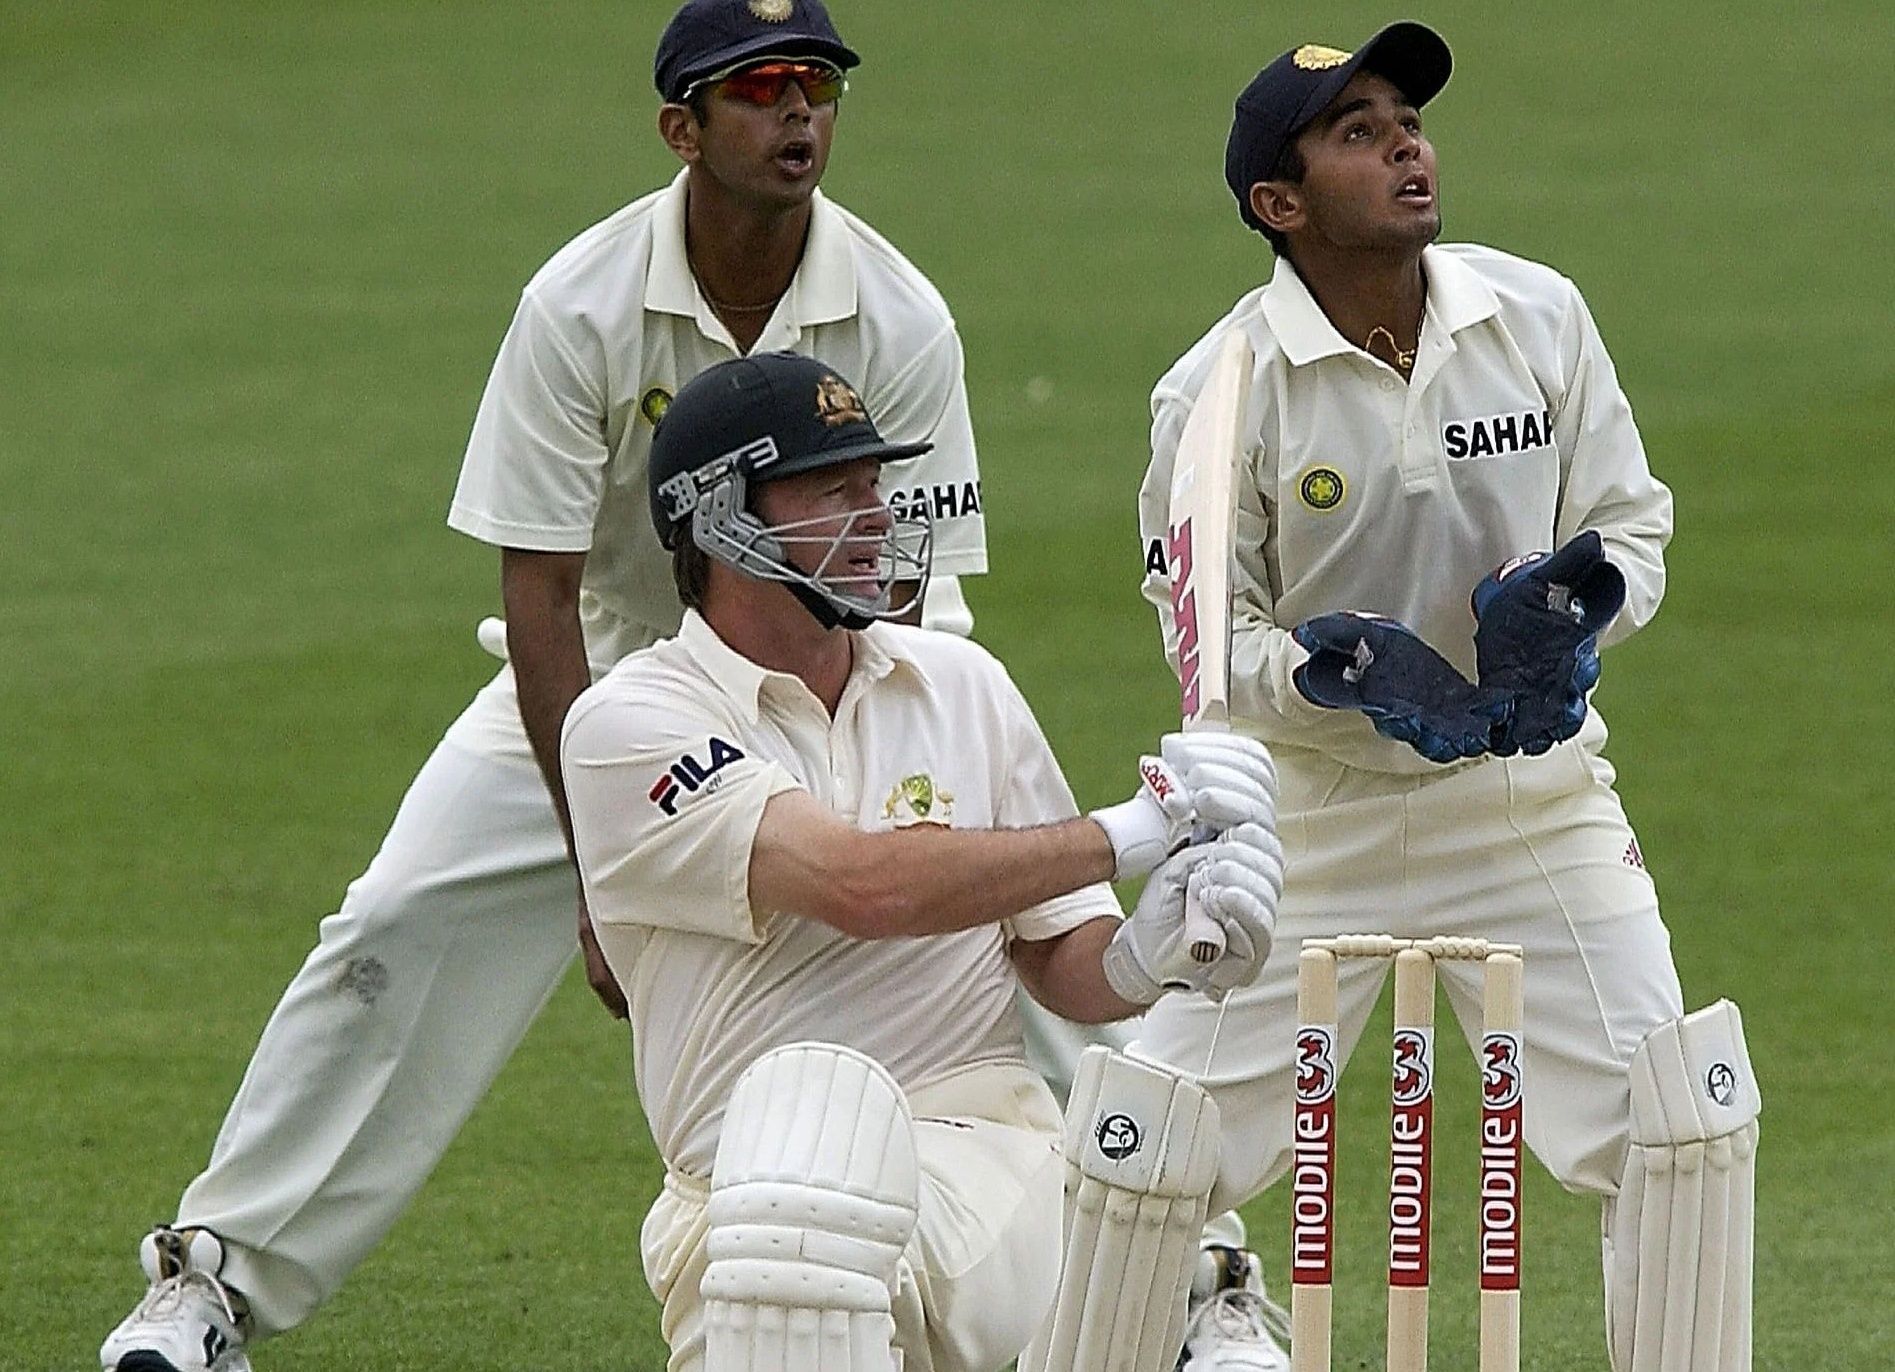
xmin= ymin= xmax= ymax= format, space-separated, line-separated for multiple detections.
xmin=0 ymin=0 xmax=1895 ymax=1372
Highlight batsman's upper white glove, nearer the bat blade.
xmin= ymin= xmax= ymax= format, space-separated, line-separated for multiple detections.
xmin=1092 ymin=731 xmax=1277 ymax=881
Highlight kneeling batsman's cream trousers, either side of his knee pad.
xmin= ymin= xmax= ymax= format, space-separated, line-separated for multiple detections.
xmin=639 ymin=1063 xmax=1065 ymax=1372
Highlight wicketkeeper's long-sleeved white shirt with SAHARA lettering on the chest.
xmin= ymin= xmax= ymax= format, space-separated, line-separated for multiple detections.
xmin=1139 ymin=243 xmax=1671 ymax=775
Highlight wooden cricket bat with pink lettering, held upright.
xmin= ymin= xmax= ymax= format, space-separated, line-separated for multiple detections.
xmin=1165 ymin=328 xmax=1253 ymax=963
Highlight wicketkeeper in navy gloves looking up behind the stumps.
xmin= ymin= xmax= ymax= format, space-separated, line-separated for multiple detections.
xmin=1038 ymin=23 xmax=1760 ymax=1372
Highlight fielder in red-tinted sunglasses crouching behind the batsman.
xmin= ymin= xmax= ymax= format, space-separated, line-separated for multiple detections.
xmin=100 ymin=0 xmax=985 ymax=1372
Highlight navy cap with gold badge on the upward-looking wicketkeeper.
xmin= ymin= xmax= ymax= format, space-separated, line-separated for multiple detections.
xmin=1224 ymin=21 xmax=1453 ymax=231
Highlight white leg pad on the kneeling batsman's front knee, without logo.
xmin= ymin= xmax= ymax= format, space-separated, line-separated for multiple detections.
xmin=699 ymin=1042 xmax=921 ymax=1372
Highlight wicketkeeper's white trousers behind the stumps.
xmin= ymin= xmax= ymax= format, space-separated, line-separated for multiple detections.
xmin=1135 ymin=731 xmax=1685 ymax=1215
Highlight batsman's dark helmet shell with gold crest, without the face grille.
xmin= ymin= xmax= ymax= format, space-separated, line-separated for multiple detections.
xmin=648 ymin=352 xmax=934 ymax=548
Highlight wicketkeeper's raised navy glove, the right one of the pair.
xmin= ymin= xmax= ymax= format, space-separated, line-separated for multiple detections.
xmin=1474 ymin=529 xmax=1626 ymax=756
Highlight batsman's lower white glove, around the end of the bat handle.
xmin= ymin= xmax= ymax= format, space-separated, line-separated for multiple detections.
xmin=1103 ymin=824 xmax=1283 ymax=1004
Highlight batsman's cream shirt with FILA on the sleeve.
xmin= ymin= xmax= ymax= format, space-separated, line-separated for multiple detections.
xmin=561 ymin=612 xmax=1120 ymax=1177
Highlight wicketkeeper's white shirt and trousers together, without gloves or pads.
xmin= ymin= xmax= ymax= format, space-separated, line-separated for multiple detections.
xmin=1139 ymin=244 xmax=1683 ymax=1243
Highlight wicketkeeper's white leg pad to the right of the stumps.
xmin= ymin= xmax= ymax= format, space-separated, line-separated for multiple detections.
xmin=1605 ymin=1001 xmax=1762 ymax=1372
